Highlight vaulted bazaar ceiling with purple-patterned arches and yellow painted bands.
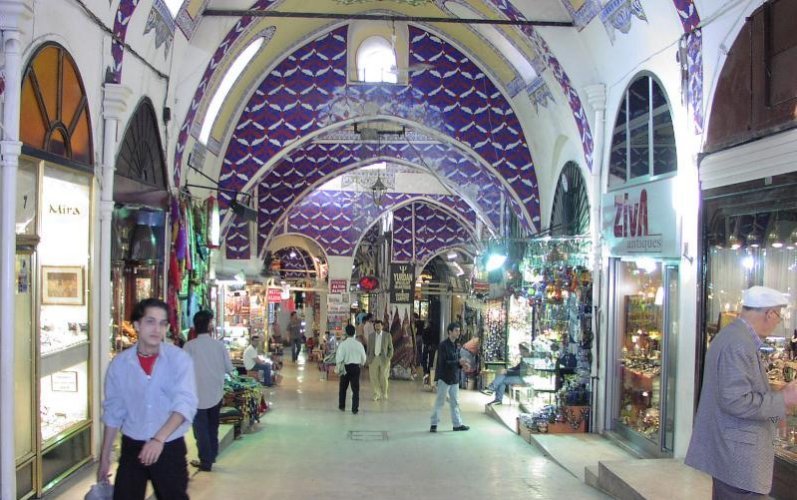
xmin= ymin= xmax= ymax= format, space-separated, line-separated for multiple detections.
xmin=105 ymin=0 xmax=702 ymax=261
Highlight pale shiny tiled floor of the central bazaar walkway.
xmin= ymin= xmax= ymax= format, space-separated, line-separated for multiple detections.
xmin=56 ymin=354 xmax=607 ymax=500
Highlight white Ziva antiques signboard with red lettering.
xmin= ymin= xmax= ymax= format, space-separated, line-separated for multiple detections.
xmin=601 ymin=178 xmax=681 ymax=258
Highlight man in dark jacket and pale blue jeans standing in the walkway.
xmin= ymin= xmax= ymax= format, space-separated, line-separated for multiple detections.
xmin=429 ymin=323 xmax=470 ymax=432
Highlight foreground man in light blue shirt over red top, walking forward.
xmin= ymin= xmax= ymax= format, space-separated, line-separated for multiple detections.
xmin=97 ymin=299 xmax=198 ymax=500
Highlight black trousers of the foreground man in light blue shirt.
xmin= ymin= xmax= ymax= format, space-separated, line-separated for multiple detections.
xmin=113 ymin=435 xmax=188 ymax=500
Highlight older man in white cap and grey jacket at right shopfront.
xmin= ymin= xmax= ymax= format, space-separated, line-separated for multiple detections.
xmin=685 ymin=286 xmax=797 ymax=500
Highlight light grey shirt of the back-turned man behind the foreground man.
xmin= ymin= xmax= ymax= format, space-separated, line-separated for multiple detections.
xmin=183 ymin=333 xmax=234 ymax=410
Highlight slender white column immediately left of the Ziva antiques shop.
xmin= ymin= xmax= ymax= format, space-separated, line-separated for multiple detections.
xmin=584 ymin=83 xmax=611 ymax=432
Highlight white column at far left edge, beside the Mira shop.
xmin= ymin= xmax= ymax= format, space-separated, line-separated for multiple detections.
xmin=0 ymin=0 xmax=33 ymax=498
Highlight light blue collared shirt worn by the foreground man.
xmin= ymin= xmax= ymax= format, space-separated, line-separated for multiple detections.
xmin=102 ymin=343 xmax=198 ymax=441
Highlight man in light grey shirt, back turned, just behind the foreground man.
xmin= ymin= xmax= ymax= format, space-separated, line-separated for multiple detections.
xmin=184 ymin=310 xmax=234 ymax=472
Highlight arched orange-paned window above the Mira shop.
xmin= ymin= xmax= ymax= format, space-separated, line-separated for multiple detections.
xmin=20 ymin=44 xmax=93 ymax=165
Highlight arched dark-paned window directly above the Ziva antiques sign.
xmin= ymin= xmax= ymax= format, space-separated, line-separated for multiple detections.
xmin=609 ymin=76 xmax=677 ymax=188
